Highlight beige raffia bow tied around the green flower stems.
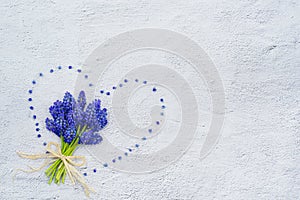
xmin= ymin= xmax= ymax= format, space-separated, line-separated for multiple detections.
xmin=17 ymin=142 xmax=95 ymax=197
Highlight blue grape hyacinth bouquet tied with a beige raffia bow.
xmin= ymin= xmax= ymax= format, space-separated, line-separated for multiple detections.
xmin=18 ymin=91 xmax=107 ymax=196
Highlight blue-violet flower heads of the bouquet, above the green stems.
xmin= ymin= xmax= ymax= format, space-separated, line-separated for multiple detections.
xmin=46 ymin=91 xmax=107 ymax=144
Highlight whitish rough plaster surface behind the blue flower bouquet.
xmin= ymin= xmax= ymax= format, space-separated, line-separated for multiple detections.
xmin=0 ymin=0 xmax=300 ymax=200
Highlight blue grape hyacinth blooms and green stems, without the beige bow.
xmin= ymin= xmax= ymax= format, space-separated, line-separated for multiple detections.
xmin=45 ymin=91 xmax=107 ymax=184
